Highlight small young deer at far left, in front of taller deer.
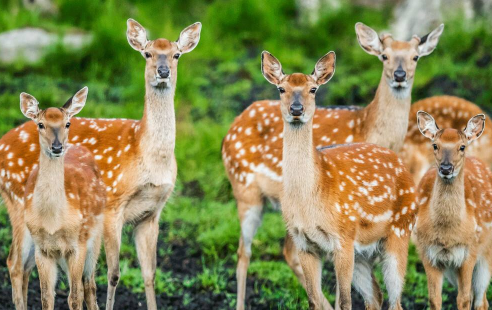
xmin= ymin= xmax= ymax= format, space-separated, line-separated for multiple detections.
xmin=15 ymin=87 xmax=106 ymax=310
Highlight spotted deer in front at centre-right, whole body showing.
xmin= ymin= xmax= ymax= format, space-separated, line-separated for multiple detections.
xmin=262 ymin=51 xmax=417 ymax=310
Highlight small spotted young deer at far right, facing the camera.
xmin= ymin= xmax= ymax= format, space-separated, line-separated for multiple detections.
xmin=414 ymin=111 xmax=492 ymax=310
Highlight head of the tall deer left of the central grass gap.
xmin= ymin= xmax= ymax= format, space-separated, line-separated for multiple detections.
xmin=126 ymin=18 xmax=202 ymax=88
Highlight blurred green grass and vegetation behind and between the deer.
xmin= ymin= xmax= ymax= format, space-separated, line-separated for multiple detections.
xmin=0 ymin=0 xmax=492 ymax=309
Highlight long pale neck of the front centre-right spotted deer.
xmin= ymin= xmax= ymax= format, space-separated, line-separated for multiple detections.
xmin=282 ymin=119 xmax=319 ymax=208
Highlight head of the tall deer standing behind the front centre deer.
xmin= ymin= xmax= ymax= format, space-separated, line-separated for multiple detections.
xmin=355 ymin=23 xmax=444 ymax=98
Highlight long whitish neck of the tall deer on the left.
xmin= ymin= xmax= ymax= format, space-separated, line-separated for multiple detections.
xmin=139 ymin=82 xmax=176 ymax=163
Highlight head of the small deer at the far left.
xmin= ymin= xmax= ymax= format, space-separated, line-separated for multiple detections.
xmin=20 ymin=87 xmax=89 ymax=158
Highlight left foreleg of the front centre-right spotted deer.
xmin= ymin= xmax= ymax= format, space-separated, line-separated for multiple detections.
xmin=298 ymin=251 xmax=332 ymax=310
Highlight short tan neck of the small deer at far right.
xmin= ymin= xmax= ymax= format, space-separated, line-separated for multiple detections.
xmin=430 ymin=165 xmax=466 ymax=229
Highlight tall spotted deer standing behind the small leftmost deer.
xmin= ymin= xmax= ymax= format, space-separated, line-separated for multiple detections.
xmin=0 ymin=19 xmax=201 ymax=309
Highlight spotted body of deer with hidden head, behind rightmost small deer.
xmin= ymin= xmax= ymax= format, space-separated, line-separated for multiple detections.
xmin=399 ymin=96 xmax=492 ymax=183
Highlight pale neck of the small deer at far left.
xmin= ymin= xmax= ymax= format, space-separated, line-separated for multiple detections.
xmin=32 ymin=151 xmax=67 ymax=224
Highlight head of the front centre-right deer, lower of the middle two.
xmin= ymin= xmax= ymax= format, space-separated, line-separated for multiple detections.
xmin=261 ymin=51 xmax=335 ymax=125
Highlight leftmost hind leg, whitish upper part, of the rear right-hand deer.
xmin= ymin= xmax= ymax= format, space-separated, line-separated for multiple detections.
xmin=236 ymin=199 xmax=263 ymax=310
